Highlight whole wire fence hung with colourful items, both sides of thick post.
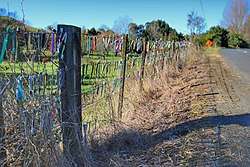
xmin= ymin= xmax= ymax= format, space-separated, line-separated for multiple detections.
xmin=0 ymin=24 xmax=190 ymax=166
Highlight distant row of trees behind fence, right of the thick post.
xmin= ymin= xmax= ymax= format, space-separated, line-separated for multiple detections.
xmin=82 ymin=17 xmax=185 ymax=41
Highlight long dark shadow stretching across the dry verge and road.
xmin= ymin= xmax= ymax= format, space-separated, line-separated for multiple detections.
xmin=96 ymin=114 xmax=250 ymax=152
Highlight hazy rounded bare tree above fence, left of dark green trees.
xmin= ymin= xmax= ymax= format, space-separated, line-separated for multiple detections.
xmin=112 ymin=16 xmax=132 ymax=34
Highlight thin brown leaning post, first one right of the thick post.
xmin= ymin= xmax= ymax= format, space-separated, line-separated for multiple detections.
xmin=118 ymin=34 xmax=128 ymax=119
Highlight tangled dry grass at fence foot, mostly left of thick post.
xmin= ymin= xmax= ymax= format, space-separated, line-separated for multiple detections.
xmin=0 ymin=85 xmax=93 ymax=167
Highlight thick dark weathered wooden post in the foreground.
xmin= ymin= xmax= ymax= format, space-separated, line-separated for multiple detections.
xmin=57 ymin=25 xmax=83 ymax=166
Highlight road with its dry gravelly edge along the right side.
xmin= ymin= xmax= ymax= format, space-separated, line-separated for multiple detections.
xmin=210 ymin=49 xmax=250 ymax=167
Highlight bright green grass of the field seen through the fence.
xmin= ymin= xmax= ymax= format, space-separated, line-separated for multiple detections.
xmin=0 ymin=55 xmax=141 ymax=93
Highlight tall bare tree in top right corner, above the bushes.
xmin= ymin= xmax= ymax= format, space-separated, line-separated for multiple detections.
xmin=223 ymin=0 xmax=249 ymax=33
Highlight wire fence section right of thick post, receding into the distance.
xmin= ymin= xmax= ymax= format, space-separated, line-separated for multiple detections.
xmin=82 ymin=35 xmax=190 ymax=136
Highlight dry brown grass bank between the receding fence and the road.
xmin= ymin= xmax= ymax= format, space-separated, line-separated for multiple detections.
xmin=87 ymin=45 xmax=216 ymax=166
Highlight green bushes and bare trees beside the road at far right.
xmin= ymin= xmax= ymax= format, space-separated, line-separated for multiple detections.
xmin=187 ymin=0 xmax=250 ymax=48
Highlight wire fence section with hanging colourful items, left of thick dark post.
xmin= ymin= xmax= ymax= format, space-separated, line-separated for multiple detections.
xmin=0 ymin=28 xmax=65 ymax=166
